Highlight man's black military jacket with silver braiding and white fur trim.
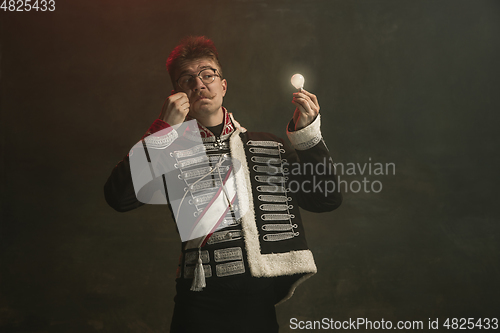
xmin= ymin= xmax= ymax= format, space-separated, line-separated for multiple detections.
xmin=104 ymin=109 xmax=342 ymax=303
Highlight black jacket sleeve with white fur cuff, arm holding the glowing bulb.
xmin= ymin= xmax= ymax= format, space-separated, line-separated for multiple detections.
xmin=286 ymin=115 xmax=342 ymax=212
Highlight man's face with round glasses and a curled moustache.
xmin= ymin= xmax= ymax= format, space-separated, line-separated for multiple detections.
xmin=174 ymin=58 xmax=227 ymax=119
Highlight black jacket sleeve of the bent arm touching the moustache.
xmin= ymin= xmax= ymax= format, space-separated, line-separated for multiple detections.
xmin=104 ymin=119 xmax=170 ymax=212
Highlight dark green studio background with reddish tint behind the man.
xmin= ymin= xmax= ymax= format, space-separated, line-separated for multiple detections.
xmin=0 ymin=0 xmax=500 ymax=333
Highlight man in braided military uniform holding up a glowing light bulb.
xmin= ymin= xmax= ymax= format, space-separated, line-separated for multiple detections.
xmin=104 ymin=37 xmax=342 ymax=332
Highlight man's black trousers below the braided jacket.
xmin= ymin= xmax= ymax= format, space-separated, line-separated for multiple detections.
xmin=170 ymin=279 xmax=279 ymax=333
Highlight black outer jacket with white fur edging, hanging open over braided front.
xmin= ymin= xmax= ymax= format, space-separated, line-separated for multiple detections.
xmin=104 ymin=110 xmax=342 ymax=303
